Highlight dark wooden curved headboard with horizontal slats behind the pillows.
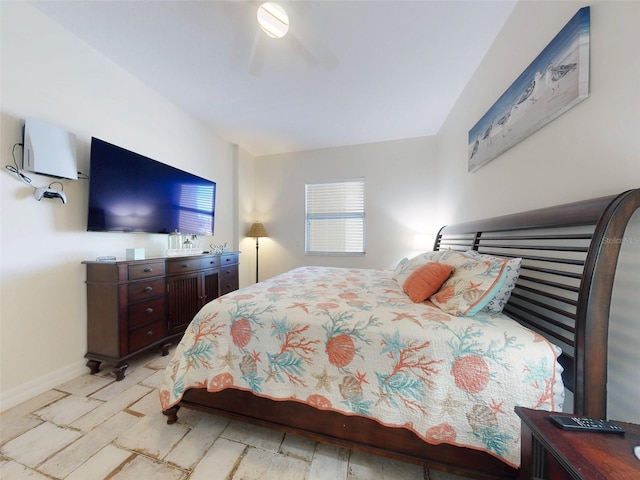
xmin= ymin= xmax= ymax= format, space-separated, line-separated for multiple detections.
xmin=434 ymin=189 xmax=640 ymax=418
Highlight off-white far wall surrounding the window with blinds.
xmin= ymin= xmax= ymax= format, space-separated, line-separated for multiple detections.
xmin=256 ymin=137 xmax=446 ymax=279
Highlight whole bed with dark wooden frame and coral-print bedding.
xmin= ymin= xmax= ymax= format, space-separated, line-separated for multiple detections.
xmin=160 ymin=189 xmax=640 ymax=478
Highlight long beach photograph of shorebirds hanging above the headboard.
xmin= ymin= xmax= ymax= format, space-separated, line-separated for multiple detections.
xmin=468 ymin=7 xmax=590 ymax=172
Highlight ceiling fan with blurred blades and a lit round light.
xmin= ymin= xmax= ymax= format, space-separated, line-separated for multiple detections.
xmin=242 ymin=1 xmax=339 ymax=76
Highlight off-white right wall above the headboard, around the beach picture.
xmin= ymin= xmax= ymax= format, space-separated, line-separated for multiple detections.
xmin=438 ymin=1 xmax=640 ymax=221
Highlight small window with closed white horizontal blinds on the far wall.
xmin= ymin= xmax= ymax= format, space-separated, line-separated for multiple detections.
xmin=305 ymin=179 xmax=365 ymax=254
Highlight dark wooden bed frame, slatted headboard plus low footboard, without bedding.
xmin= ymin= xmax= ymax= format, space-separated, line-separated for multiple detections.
xmin=164 ymin=189 xmax=640 ymax=478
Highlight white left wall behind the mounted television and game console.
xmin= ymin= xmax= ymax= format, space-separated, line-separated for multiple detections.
xmin=0 ymin=2 xmax=246 ymax=408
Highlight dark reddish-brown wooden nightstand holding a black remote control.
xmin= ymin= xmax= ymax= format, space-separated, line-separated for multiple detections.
xmin=515 ymin=407 xmax=640 ymax=480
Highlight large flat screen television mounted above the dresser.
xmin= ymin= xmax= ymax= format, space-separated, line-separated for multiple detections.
xmin=87 ymin=138 xmax=216 ymax=235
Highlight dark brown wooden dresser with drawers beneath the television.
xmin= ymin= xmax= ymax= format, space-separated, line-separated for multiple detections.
xmin=83 ymin=252 xmax=239 ymax=380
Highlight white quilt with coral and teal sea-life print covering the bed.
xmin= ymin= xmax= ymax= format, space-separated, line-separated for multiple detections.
xmin=160 ymin=267 xmax=561 ymax=467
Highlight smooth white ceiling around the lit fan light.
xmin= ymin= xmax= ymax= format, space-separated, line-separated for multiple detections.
xmin=32 ymin=0 xmax=516 ymax=156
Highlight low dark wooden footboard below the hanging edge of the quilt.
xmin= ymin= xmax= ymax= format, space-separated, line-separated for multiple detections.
xmin=164 ymin=389 xmax=518 ymax=479
